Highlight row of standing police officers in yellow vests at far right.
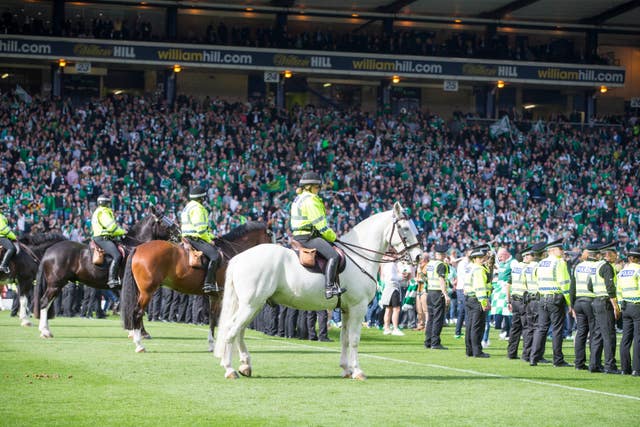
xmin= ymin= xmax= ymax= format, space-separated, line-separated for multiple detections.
xmin=504 ymin=240 xmax=640 ymax=376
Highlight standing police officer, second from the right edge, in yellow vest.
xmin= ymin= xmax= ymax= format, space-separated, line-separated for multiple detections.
xmin=590 ymin=242 xmax=621 ymax=374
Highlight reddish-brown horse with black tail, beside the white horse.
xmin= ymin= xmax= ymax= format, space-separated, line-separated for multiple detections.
xmin=120 ymin=222 xmax=272 ymax=353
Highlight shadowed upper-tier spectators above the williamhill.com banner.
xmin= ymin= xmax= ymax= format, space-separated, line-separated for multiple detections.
xmin=0 ymin=10 xmax=609 ymax=64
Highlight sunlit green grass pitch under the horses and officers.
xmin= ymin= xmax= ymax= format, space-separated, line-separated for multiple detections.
xmin=0 ymin=311 xmax=640 ymax=426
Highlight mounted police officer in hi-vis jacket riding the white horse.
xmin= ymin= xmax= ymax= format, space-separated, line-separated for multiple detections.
xmin=291 ymin=172 xmax=346 ymax=299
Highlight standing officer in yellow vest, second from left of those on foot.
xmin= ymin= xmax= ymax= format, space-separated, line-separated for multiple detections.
xmin=464 ymin=245 xmax=491 ymax=357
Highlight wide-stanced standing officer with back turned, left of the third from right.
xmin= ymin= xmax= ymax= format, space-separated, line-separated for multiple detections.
xmin=529 ymin=239 xmax=572 ymax=368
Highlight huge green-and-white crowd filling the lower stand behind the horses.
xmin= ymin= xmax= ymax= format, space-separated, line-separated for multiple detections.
xmin=0 ymin=90 xmax=640 ymax=262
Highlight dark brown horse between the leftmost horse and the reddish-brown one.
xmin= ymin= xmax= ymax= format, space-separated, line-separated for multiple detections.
xmin=33 ymin=208 xmax=179 ymax=338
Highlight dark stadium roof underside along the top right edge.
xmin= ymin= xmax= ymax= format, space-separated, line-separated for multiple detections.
xmin=189 ymin=0 xmax=640 ymax=32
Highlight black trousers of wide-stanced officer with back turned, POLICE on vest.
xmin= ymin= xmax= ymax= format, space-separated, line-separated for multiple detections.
xmin=531 ymin=294 xmax=567 ymax=365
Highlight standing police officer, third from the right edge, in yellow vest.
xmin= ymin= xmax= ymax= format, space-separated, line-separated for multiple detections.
xmin=570 ymin=244 xmax=599 ymax=370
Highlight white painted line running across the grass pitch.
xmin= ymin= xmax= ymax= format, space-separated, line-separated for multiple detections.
xmin=256 ymin=338 xmax=640 ymax=401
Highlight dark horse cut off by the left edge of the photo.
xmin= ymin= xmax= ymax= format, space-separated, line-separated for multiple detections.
xmin=0 ymin=233 xmax=67 ymax=326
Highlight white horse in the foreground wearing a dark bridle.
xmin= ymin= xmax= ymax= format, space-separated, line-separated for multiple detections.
xmin=215 ymin=202 xmax=422 ymax=380
